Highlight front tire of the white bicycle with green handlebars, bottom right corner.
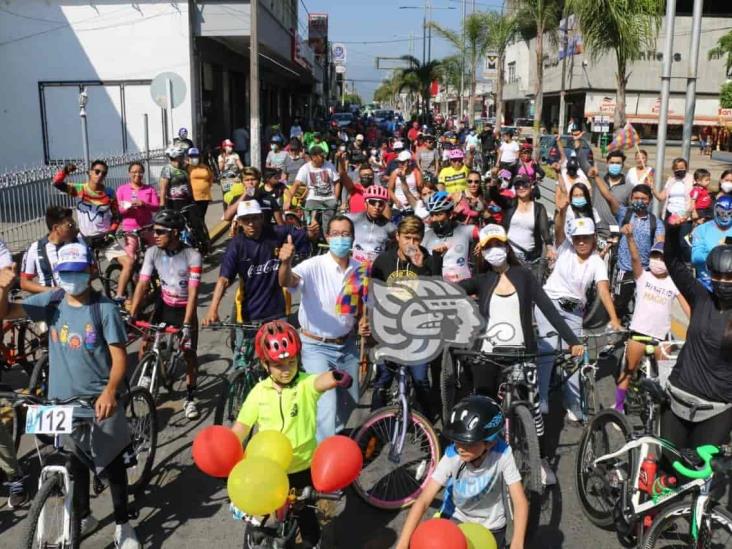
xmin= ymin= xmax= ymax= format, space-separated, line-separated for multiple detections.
xmin=643 ymin=501 xmax=732 ymax=549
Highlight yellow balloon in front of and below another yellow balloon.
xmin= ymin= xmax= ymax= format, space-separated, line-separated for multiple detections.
xmin=226 ymin=455 xmax=290 ymax=515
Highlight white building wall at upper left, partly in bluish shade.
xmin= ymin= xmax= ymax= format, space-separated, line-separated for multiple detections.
xmin=0 ymin=0 xmax=195 ymax=171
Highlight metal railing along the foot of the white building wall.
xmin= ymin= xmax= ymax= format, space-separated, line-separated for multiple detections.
xmin=0 ymin=149 xmax=167 ymax=253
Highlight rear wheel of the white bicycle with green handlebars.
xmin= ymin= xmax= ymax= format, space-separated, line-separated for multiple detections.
xmin=574 ymin=409 xmax=633 ymax=528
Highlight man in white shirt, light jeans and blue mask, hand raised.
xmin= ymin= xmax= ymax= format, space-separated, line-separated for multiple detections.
xmin=278 ymin=215 xmax=361 ymax=441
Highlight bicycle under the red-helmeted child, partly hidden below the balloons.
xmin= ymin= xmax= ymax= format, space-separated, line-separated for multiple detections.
xmin=231 ymin=486 xmax=343 ymax=549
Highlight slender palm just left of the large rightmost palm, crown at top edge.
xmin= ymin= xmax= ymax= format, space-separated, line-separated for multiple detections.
xmin=517 ymin=0 xmax=560 ymax=143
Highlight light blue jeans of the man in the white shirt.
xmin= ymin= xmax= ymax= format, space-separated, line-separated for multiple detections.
xmin=301 ymin=336 xmax=359 ymax=442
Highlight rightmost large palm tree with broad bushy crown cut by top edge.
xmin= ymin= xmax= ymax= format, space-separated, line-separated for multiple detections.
xmin=567 ymin=0 xmax=665 ymax=128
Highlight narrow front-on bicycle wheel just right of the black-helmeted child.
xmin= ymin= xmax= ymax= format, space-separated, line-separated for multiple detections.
xmin=507 ymin=404 xmax=543 ymax=494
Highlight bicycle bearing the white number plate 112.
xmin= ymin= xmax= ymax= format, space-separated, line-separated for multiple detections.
xmin=0 ymin=388 xmax=157 ymax=549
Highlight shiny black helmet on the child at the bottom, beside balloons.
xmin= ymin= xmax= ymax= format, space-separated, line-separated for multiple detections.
xmin=442 ymin=395 xmax=503 ymax=444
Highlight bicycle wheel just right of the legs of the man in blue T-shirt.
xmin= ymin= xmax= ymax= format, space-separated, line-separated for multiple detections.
xmin=125 ymin=387 xmax=158 ymax=492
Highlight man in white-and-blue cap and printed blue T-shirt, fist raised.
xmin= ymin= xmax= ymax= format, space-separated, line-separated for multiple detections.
xmin=0 ymin=243 xmax=140 ymax=548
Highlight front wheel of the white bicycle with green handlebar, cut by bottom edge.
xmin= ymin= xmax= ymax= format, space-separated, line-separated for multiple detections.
xmin=643 ymin=502 xmax=732 ymax=549
